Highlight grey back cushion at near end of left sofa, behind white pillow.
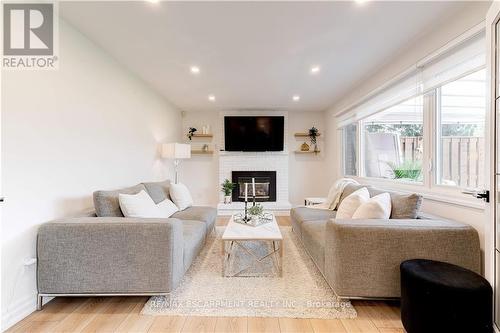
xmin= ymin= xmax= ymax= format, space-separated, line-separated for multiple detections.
xmin=93 ymin=184 xmax=146 ymax=217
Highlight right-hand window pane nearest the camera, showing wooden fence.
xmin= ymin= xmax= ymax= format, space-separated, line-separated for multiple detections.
xmin=436 ymin=69 xmax=486 ymax=189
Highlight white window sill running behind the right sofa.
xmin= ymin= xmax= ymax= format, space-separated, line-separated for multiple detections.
xmin=346 ymin=176 xmax=486 ymax=210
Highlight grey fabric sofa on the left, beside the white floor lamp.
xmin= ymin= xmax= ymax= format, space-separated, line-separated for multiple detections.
xmin=37 ymin=181 xmax=217 ymax=308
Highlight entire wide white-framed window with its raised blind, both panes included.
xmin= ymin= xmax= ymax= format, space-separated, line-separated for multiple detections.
xmin=336 ymin=30 xmax=488 ymax=197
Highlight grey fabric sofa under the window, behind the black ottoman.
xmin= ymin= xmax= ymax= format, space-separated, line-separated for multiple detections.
xmin=291 ymin=185 xmax=481 ymax=299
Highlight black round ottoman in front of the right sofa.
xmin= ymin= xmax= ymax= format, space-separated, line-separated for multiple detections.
xmin=400 ymin=259 xmax=493 ymax=333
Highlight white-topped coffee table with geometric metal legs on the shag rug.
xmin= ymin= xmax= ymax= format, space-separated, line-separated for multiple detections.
xmin=222 ymin=215 xmax=283 ymax=277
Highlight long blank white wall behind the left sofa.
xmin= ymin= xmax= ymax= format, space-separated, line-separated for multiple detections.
xmin=1 ymin=22 xmax=181 ymax=329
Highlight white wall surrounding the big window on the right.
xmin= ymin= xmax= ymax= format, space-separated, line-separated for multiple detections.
xmin=326 ymin=2 xmax=490 ymax=268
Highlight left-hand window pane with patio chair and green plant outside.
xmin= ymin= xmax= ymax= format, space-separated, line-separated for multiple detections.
xmin=361 ymin=96 xmax=424 ymax=182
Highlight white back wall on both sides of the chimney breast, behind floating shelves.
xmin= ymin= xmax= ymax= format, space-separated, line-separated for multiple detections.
xmin=180 ymin=111 xmax=330 ymax=206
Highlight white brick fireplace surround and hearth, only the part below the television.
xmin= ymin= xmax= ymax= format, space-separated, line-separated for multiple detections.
xmin=217 ymin=151 xmax=292 ymax=215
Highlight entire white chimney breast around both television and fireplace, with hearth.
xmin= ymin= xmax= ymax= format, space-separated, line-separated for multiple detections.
xmin=217 ymin=111 xmax=292 ymax=215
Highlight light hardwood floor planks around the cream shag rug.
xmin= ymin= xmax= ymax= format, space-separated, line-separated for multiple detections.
xmin=7 ymin=217 xmax=404 ymax=333
